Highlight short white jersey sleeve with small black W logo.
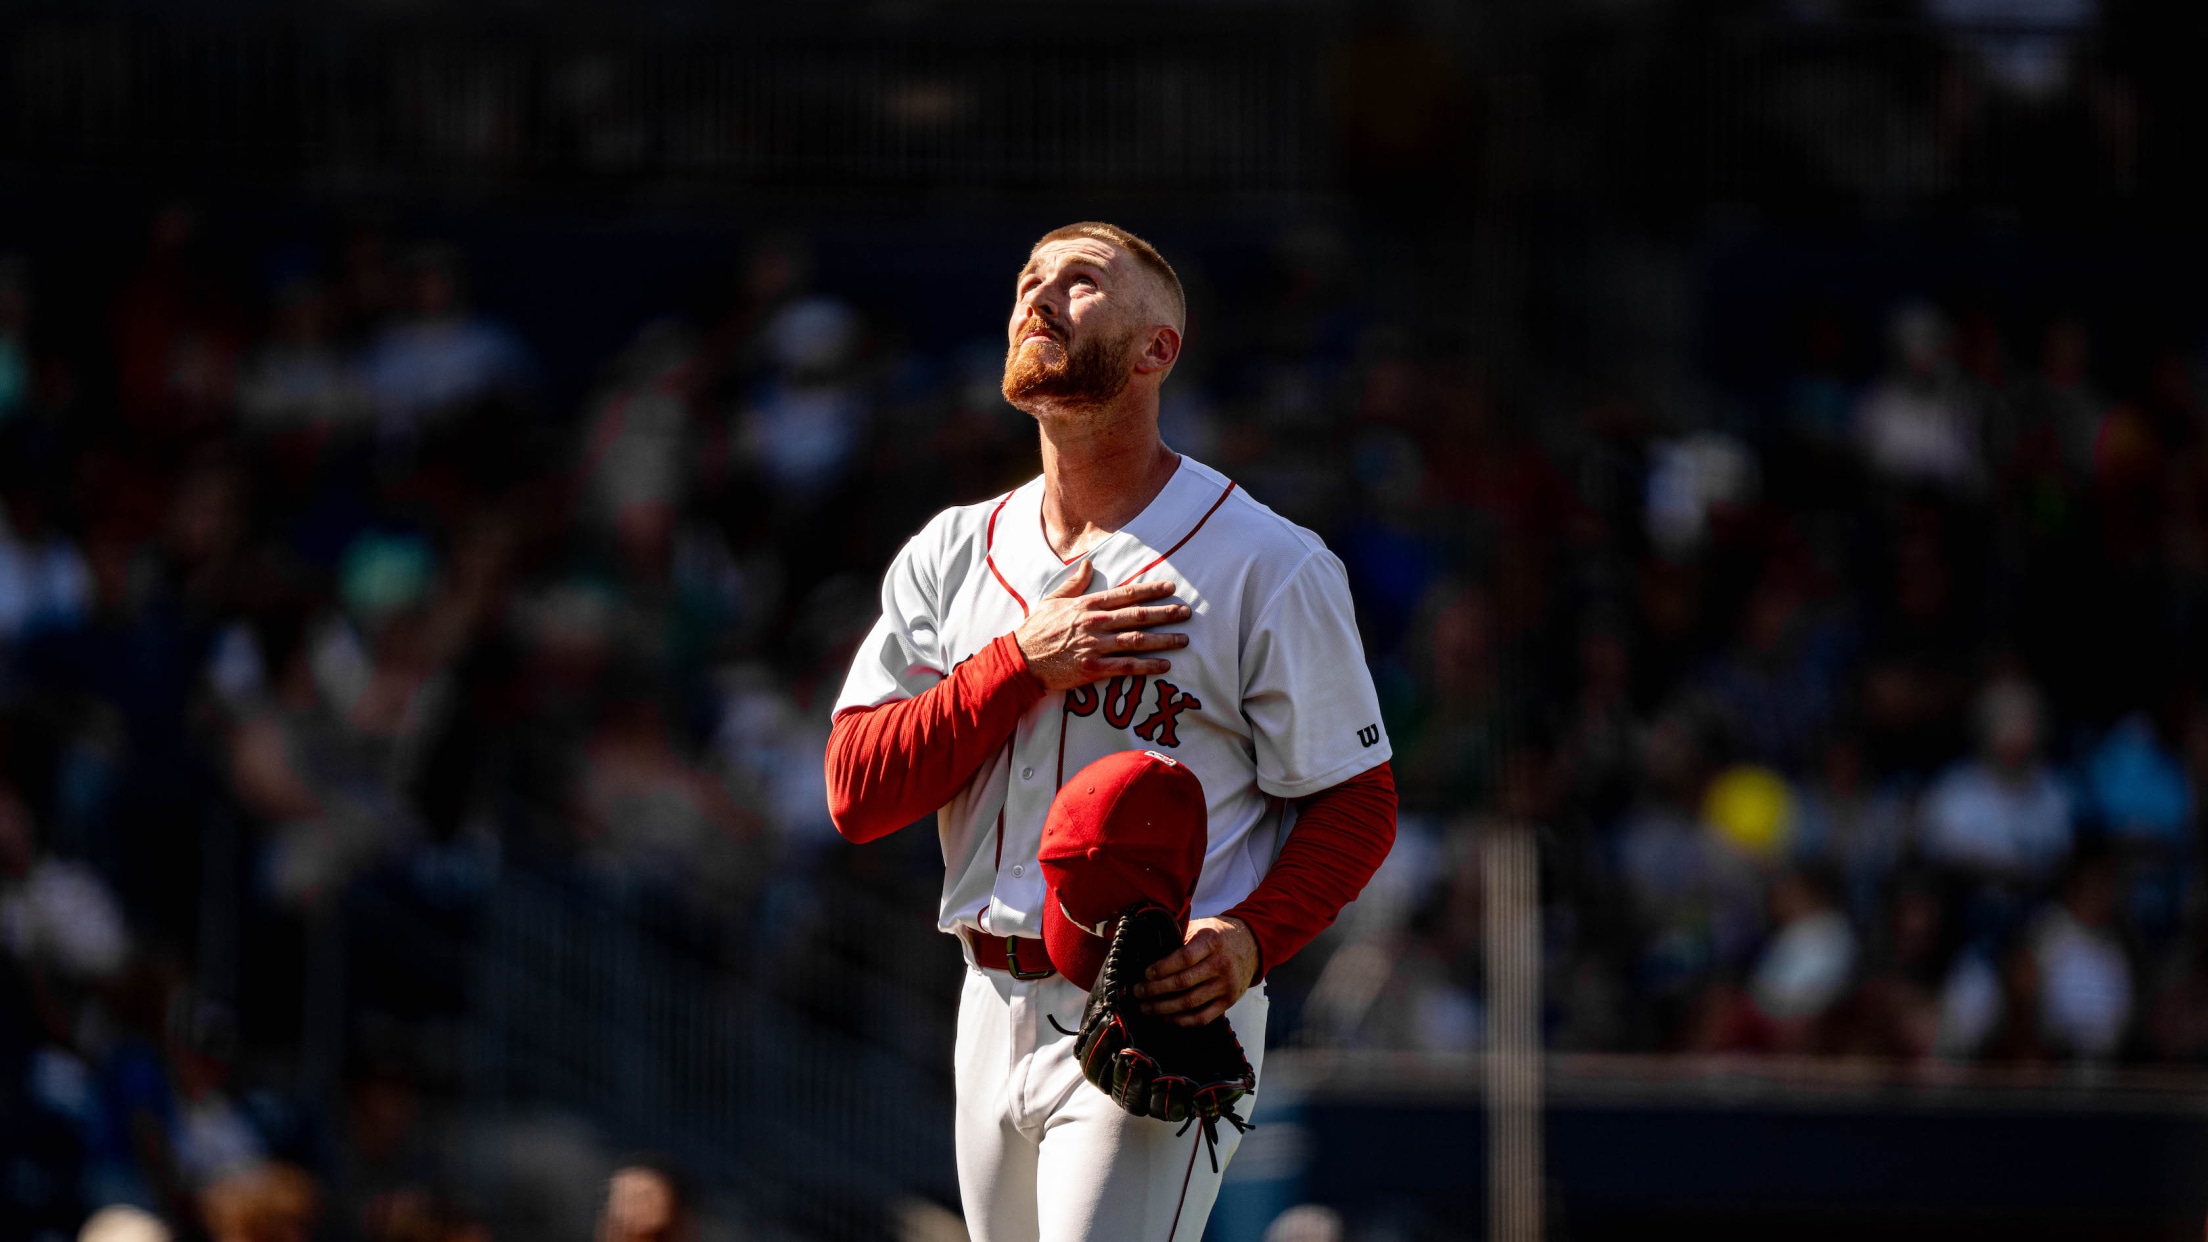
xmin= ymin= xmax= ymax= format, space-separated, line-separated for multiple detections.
xmin=1243 ymin=548 xmax=1393 ymax=798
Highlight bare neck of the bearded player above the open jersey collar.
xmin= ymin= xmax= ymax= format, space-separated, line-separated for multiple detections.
xmin=1036 ymin=406 xmax=1181 ymax=557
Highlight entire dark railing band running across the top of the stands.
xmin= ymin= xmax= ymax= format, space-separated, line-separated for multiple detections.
xmin=0 ymin=4 xmax=2137 ymax=210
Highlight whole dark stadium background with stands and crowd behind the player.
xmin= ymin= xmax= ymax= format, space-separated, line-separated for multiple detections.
xmin=0 ymin=0 xmax=2208 ymax=1242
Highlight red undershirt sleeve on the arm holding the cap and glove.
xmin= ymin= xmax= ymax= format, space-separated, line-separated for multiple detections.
xmin=1228 ymin=762 xmax=1395 ymax=979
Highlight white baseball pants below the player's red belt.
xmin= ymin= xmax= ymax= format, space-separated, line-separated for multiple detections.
xmin=956 ymin=966 xmax=1270 ymax=1242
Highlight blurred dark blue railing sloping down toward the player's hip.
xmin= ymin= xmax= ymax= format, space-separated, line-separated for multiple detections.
xmin=468 ymin=873 xmax=956 ymax=1235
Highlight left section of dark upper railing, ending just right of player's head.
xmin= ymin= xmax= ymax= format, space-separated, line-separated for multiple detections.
xmin=0 ymin=13 xmax=1327 ymax=194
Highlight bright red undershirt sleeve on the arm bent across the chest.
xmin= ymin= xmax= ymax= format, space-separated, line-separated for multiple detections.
xmin=826 ymin=634 xmax=1044 ymax=844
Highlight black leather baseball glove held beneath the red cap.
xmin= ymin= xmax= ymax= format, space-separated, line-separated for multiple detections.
xmin=1051 ymin=906 xmax=1256 ymax=1169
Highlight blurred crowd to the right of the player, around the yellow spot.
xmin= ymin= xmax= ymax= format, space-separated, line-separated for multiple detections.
xmin=1305 ymin=298 xmax=2208 ymax=1065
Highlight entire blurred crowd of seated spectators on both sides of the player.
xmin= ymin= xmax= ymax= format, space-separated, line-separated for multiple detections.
xmin=0 ymin=188 xmax=2208 ymax=1242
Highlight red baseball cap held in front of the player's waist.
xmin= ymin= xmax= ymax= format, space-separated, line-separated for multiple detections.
xmin=1036 ymin=751 xmax=1210 ymax=990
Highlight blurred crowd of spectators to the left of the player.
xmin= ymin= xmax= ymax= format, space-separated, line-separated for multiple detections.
xmin=0 ymin=206 xmax=949 ymax=1242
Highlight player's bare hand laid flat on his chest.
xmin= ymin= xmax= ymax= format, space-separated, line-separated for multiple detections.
xmin=1011 ymin=559 xmax=1190 ymax=690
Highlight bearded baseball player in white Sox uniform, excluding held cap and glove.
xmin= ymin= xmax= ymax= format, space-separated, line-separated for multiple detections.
xmin=828 ymin=223 xmax=1395 ymax=1242
